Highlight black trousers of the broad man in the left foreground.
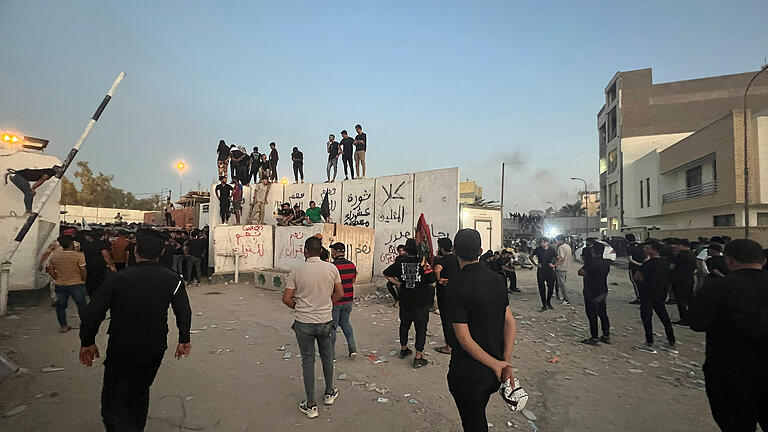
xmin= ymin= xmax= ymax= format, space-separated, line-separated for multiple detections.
xmin=101 ymin=354 xmax=163 ymax=432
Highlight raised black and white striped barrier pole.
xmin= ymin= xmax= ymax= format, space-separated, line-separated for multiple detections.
xmin=0 ymin=72 xmax=125 ymax=315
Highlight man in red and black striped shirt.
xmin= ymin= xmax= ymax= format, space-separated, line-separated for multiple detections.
xmin=331 ymin=242 xmax=357 ymax=360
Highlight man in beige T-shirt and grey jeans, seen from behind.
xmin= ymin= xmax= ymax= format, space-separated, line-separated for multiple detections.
xmin=283 ymin=236 xmax=344 ymax=418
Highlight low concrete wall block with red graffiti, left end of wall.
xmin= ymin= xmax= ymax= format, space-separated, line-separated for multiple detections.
xmin=212 ymin=225 xmax=274 ymax=273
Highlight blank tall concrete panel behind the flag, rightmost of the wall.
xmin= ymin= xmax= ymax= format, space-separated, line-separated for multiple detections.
xmin=413 ymin=168 xmax=459 ymax=254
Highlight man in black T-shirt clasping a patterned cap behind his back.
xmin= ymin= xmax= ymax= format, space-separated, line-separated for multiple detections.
xmin=444 ymin=228 xmax=517 ymax=432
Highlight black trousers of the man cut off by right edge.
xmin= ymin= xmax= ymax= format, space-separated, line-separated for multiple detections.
xmin=704 ymin=363 xmax=768 ymax=432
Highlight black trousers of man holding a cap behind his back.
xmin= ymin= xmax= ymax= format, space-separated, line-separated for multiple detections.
xmin=448 ymin=363 xmax=500 ymax=432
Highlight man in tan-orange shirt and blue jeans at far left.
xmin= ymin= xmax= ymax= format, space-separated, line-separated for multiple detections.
xmin=46 ymin=235 xmax=87 ymax=333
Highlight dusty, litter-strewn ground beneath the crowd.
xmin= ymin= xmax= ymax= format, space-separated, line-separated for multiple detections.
xmin=0 ymin=268 xmax=716 ymax=432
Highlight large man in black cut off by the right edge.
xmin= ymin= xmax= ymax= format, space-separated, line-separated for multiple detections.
xmin=688 ymin=239 xmax=768 ymax=431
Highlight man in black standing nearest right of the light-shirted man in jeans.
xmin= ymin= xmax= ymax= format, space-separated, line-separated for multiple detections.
xmin=579 ymin=242 xmax=611 ymax=345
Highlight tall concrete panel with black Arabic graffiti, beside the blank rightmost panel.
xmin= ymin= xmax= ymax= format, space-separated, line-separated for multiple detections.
xmin=373 ymin=174 xmax=415 ymax=275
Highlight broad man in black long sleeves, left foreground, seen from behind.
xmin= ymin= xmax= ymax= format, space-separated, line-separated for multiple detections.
xmin=80 ymin=229 xmax=192 ymax=431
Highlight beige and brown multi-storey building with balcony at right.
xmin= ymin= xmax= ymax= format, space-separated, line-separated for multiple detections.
xmin=598 ymin=69 xmax=768 ymax=240
